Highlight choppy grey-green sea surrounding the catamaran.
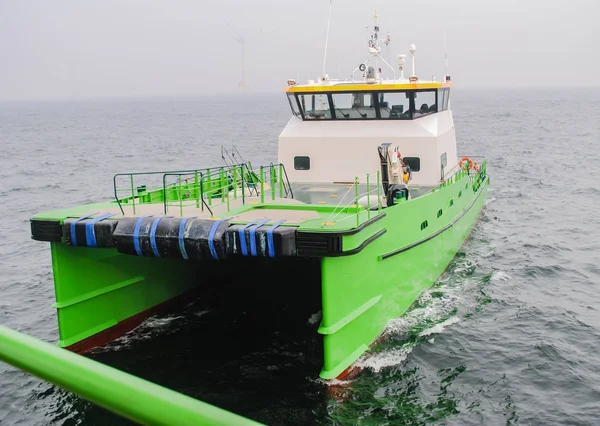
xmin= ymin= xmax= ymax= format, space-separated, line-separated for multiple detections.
xmin=0 ymin=90 xmax=600 ymax=425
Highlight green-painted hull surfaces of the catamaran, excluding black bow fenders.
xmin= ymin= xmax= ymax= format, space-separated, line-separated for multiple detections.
xmin=32 ymin=165 xmax=489 ymax=379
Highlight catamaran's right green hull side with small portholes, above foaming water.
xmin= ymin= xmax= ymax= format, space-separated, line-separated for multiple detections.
xmin=319 ymin=180 xmax=487 ymax=379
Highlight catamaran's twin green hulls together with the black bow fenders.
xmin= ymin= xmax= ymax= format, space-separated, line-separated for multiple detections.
xmin=32 ymin=166 xmax=489 ymax=379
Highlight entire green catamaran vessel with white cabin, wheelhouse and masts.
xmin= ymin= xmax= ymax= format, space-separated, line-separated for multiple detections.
xmin=0 ymin=10 xmax=489 ymax=426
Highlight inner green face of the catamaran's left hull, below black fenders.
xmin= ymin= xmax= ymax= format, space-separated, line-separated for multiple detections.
xmin=51 ymin=243 xmax=201 ymax=352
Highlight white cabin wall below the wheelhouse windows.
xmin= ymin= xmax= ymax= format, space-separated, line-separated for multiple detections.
xmin=278 ymin=111 xmax=456 ymax=185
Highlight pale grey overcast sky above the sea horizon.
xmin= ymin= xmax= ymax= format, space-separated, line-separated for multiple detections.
xmin=0 ymin=0 xmax=600 ymax=100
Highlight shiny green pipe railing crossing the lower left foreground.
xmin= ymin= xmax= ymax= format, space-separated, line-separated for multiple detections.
xmin=0 ymin=326 xmax=260 ymax=426
